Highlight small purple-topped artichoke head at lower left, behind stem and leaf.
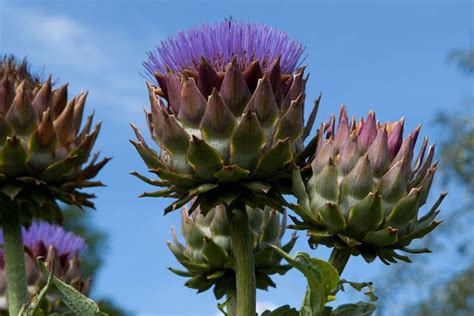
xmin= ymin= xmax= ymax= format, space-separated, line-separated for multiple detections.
xmin=0 ymin=222 xmax=90 ymax=313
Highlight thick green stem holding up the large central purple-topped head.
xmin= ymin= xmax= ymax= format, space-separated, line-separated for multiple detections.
xmin=227 ymin=208 xmax=256 ymax=316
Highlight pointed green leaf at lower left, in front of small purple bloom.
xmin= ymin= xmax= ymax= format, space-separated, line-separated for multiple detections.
xmin=36 ymin=259 xmax=107 ymax=316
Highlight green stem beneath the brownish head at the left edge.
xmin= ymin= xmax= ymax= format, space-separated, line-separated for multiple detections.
xmin=3 ymin=210 xmax=27 ymax=316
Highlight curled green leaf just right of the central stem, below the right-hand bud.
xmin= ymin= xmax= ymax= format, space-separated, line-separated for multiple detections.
xmin=268 ymin=245 xmax=339 ymax=316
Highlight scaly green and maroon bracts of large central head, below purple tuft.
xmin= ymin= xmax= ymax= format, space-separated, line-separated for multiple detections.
xmin=132 ymin=58 xmax=317 ymax=213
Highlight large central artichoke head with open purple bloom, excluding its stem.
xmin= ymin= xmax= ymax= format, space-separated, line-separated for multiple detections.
xmin=132 ymin=21 xmax=317 ymax=213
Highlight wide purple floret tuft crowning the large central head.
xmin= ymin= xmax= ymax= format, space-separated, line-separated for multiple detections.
xmin=143 ymin=20 xmax=305 ymax=78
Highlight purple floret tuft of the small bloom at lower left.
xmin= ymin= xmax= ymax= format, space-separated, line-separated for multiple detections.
xmin=0 ymin=222 xmax=86 ymax=269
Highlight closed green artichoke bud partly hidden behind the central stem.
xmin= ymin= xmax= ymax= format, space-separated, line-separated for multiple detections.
xmin=168 ymin=205 xmax=296 ymax=299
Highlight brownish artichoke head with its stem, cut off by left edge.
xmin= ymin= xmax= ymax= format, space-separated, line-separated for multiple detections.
xmin=0 ymin=57 xmax=109 ymax=315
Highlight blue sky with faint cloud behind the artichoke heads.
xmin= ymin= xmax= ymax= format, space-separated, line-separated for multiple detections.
xmin=0 ymin=0 xmax=474 ymax=315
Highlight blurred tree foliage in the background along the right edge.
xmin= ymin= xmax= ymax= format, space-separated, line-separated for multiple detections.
xmin=377 ymin=48 xmax=474 ymax=316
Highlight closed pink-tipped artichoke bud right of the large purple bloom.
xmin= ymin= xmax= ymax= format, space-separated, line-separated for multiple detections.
xmin=293 ymin=107 xmax=445 ymax=264
